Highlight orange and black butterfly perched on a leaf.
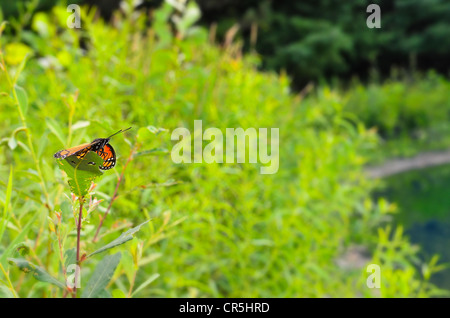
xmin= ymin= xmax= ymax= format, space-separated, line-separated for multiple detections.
xmin=53 ymin=127 xmax=131 ymax=170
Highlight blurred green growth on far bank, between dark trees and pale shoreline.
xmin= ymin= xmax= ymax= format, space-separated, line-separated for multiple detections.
xmin=343 ymin=72 xmax=450 ymax=161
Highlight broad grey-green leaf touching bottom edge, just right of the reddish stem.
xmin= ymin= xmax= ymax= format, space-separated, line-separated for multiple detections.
xmin=81 ymin=252 xmax=121 ymax=298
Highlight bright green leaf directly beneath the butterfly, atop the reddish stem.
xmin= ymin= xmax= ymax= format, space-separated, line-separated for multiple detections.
xmin=58 ymin=151 xmax=103 ymax=197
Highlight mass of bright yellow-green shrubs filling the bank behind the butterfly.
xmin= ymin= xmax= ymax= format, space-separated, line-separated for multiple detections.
xmin=0 ymin=4 xmax=448 ymax=297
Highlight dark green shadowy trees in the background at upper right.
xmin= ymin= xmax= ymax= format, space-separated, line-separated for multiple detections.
xmin=197 ymin=0 xmax=450 ymax=85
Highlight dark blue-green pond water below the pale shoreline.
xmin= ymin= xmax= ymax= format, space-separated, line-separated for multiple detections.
xmin=375 ymin=164 xmax=450 ymax=290
